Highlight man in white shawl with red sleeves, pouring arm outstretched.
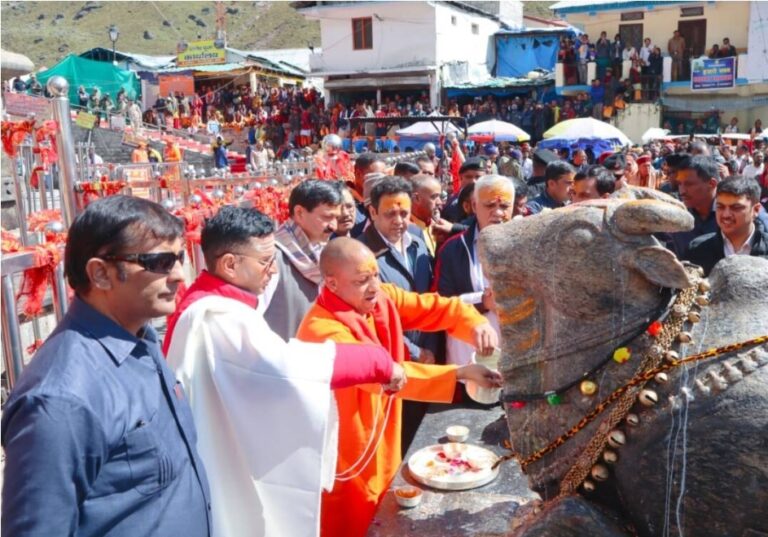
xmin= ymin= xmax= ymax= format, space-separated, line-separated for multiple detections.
xmin=164 ymin=205 xmax=404 ymax=537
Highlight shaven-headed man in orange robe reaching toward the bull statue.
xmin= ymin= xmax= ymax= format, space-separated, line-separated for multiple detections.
xmin=297 ymin=237 xmax=501 ymax=537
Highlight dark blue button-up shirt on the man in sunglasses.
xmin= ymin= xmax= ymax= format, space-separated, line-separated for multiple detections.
xmin=2 ymin=298 xmax=210 ymax=537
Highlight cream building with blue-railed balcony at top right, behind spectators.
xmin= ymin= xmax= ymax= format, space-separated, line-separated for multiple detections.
xmin=551 ymin=0 xmax=768 ymax=140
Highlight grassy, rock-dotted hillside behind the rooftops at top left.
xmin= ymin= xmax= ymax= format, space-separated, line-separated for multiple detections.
xmin=0 ymin=0 xmax=320 ymax=68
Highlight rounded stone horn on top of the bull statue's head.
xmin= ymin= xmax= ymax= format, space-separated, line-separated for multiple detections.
xmin=612 ymin=199 xmax=693 ymax=235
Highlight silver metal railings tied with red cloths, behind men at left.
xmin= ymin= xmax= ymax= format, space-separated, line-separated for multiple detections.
xmin=0 ymin=78 xmax=432 ymax=388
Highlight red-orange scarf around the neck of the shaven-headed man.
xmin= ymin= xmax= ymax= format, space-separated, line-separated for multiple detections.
xmin=317 ymin=286 xmax=406 ymax=363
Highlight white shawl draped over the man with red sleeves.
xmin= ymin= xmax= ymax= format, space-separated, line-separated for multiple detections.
xmin=168 ymin=295 xmax=338 ymax=537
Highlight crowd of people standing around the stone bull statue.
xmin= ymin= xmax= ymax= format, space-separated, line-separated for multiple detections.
xmin=2 ymin=118 xmax=768 ymax=537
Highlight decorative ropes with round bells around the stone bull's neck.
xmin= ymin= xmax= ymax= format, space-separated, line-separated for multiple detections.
xmin=496 ymin=267 xmax=768 ymax=496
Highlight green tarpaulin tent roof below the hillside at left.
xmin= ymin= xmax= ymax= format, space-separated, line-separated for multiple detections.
xmin=37 ymin=54 xmax=141 ymax=105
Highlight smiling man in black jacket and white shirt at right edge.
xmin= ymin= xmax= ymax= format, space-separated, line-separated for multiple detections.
xmin=686 ymin=176 xmax=768 ymax=275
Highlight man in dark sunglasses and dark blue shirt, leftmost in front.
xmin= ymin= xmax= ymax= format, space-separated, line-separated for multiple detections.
xmin=2 ymin=196 xmax=210 ymax=537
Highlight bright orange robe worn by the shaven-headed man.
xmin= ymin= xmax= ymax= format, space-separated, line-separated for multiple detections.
xmin=296 ymin=284 xmax=486 ymax=537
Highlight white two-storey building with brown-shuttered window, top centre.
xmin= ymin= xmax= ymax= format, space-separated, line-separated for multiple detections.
xmin=293 ymin=0 xmax=523 ymax=107
